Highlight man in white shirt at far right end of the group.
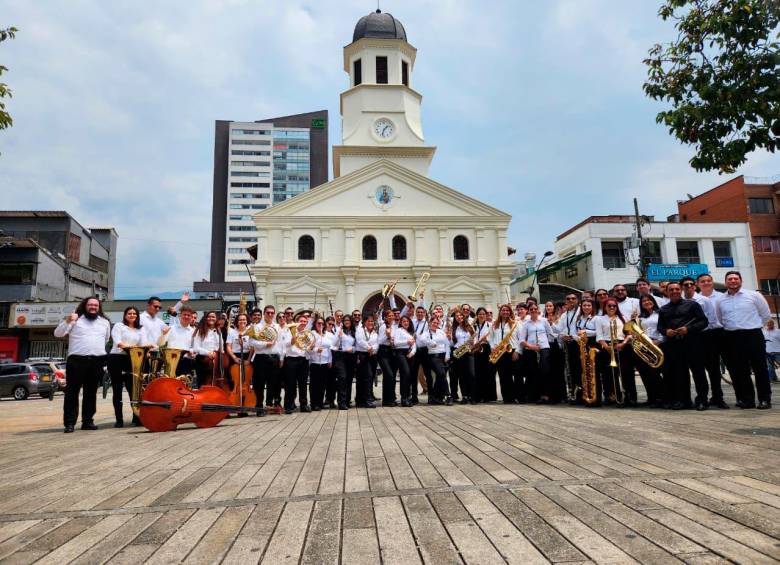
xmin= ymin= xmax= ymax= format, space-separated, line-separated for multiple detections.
xmin=716 ymin=271 xmax=772 ymax=409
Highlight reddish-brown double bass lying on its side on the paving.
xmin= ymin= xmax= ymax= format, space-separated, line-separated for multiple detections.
xmin=135 ymin=377 xmax=245 ymax=432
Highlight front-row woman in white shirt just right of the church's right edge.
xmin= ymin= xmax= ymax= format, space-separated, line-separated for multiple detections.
xmin=520 ymin=304 xmax=560 ymax=403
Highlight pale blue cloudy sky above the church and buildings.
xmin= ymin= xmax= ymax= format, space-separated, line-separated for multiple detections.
xmin=0 ymin=0 xmax=780 ymax=296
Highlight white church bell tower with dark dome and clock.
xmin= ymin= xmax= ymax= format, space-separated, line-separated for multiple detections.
xmin=333 ymin=10 xmax=436 ymax=177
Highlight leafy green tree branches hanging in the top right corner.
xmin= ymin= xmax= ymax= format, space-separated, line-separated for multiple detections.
xmin=644 ymin=0 xmax=780 ymax=173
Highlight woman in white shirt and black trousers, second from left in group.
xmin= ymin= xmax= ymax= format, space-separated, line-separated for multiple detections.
xmin=108 ymin=306 xmax=148 ymax=428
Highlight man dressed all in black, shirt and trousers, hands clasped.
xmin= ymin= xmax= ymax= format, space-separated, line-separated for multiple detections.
xmin=658 ymin=282 xmax=709 ymax=410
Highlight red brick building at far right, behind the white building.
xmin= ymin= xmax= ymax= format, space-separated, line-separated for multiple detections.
xmin=677 ymin=176 xmax=780 ymax=312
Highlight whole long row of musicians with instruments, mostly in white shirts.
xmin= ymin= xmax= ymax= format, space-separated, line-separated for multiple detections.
xmin=54 ymin=271 xmax=771 ymax=433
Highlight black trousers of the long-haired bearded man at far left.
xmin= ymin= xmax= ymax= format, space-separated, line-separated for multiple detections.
xmin=62 ymin=355 xmax=106 ymax=426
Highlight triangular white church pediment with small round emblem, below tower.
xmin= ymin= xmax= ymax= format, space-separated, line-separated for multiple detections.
xmin=254 ymin=160 xmax=511 ymax=223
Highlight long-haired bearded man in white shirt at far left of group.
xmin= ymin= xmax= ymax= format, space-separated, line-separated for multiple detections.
xmin=54 ymin=297 xmax=111 ymax=434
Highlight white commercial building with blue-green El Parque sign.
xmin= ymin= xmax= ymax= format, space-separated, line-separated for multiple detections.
xmin=519 ymin=216 xmax=757 ymax=290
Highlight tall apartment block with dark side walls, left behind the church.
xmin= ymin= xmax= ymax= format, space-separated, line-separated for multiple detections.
xmin=204 ymin=110 xmax=328 ymax=286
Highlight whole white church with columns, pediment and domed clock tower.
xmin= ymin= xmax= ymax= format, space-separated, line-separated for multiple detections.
xmin=252 ymin=11 xmax=513 ymax=311
